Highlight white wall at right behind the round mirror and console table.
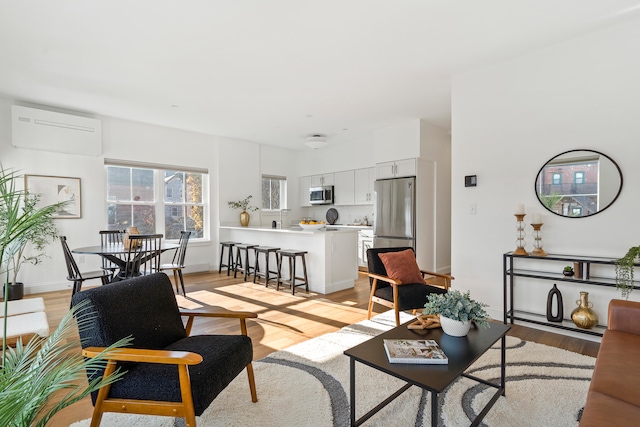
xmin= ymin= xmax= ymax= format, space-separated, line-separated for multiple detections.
xmin=452 ymin=15 xmax=640 ymax=322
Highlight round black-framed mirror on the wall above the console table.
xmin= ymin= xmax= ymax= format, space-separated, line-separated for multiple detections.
xmin=535 ymin=150 xmax=622 ymax=218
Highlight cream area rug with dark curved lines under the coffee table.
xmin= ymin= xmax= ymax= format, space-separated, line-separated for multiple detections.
xmin=72 ymin=313 xmax=595 ymax=427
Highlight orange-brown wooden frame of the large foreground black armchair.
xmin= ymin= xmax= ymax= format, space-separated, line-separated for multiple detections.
xmin=82 ymin=310 xmax=258 ymax=427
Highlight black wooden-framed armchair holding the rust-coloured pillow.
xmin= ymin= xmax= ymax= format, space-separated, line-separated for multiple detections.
xmin=367 ymin=247 xmax=453 ymax=325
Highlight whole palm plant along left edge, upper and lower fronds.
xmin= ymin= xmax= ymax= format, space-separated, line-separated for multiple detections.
xmin=0 ymin=166 xmax=130 ymax=427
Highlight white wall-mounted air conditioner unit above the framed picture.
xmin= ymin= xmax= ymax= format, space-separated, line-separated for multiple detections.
xmin=11 ymin=105 xmax=102 ymax=156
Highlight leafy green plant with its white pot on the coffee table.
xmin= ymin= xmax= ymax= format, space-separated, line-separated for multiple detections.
xmin=423 ymin=290 xmax=489 ymax=337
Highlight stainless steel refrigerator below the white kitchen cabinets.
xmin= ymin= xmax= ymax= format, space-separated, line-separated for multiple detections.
xmin=373 ymin=177 xmax=416 ymax=250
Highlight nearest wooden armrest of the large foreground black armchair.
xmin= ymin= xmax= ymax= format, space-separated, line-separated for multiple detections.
xmin=82 ymin=347 xmax=202 ymax=365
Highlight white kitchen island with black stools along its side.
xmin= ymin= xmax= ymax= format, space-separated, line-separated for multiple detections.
xmin=219 ymin=226 xmax=358 ymax=294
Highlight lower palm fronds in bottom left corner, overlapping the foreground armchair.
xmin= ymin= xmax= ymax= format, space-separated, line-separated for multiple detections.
xmin=0 ymin=301 xmax=131 ymax=427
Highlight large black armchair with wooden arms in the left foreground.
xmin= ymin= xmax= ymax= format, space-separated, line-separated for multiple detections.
xmin=72 ymin=273 xmax=258 ymax=427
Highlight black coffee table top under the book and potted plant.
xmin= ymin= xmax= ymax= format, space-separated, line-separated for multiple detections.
xmin=344 ymin=322 xmax=511 ymax=393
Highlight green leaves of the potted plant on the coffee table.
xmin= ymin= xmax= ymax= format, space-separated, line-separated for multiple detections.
xmin=423 ymin=290 xmax=489 ymax=326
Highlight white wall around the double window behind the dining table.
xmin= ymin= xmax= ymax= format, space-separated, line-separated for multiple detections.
xmin=0 ymin=97 xmax=270 ymax=293
